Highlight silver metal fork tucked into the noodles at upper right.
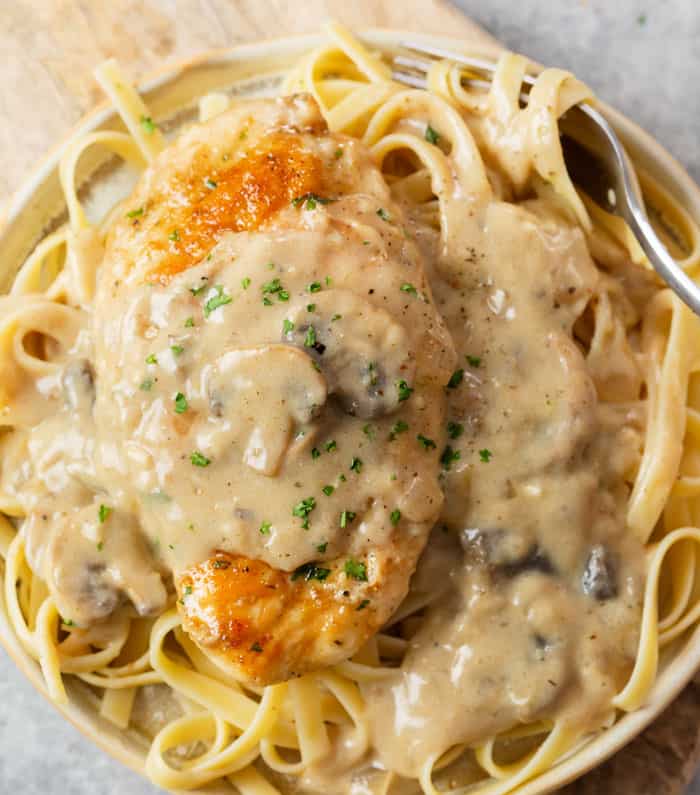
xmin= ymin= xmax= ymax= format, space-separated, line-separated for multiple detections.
xmin=392 ymin=43 xmax=700 ymax=315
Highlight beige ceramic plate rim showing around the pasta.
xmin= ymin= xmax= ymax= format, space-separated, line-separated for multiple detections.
xmin=0 ymin=30 xmax=700 ymax=795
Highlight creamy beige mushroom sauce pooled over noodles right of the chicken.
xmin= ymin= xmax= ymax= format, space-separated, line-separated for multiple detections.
xmin=364 ymin=201 xmax=645 ymax=777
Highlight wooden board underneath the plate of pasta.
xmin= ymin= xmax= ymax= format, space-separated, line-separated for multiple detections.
xmin=0 ymin=0 xmax=700 ymax=795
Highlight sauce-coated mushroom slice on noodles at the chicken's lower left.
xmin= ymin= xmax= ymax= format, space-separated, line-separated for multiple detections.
xmin=44 ymin=505 xmax=167 ymax=626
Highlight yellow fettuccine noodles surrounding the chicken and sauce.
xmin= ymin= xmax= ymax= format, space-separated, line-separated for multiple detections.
xmin=0 ymin=25 xmax=700 ymax=795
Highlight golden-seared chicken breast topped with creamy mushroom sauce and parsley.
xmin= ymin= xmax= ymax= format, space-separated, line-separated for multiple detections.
xmin=89 ymin=96 xmax=454 ymax=684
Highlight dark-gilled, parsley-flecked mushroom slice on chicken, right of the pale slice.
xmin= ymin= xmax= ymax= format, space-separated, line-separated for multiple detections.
xmin=284 ymin=290 xmax=415 ymax=419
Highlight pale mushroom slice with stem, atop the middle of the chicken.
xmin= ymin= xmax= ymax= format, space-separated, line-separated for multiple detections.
xmin=207 ymin=345 xmax=327 ymax=476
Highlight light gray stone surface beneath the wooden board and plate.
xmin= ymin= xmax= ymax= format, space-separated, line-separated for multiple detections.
xmin=0 ymin=0 xmax=700 ymax=795
